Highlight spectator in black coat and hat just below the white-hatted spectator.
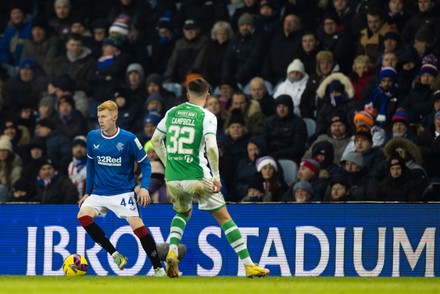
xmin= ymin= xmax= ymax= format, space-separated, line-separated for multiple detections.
xmin=263 ymin=95 xmax=307 ymax=163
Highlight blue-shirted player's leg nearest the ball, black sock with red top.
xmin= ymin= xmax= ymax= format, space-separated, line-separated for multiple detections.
xmin=78 ymin=204 xmax=127 ymax=269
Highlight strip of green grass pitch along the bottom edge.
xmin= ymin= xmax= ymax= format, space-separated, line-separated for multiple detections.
xmin=0 ymin=276 xmax=440 ymax=294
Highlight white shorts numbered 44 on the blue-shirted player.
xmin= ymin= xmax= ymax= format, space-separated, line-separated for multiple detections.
xmin=82 ymin=192 xmax=140 ymax=219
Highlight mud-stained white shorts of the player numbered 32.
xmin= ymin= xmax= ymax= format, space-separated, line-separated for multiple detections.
xmin=167 ymin=179 xmax=226 ymax=213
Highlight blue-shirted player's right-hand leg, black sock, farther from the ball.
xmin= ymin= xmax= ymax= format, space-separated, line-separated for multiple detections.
xmin=127 ymin=216 xmax=165 ymax=276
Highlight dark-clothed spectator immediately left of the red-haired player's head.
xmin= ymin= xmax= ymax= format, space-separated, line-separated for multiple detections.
xmin=55 ymin=95 xmax=88 ymax=140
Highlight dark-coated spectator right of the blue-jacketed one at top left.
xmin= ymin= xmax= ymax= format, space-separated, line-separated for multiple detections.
xmin=21 ymin=19 xmax=59 ymax=77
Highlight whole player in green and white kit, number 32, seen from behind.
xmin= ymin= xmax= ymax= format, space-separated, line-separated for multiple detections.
xmin=152 ymin=78 xmax=269 ymax=278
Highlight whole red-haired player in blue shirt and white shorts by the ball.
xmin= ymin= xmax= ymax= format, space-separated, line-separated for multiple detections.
xmin=78 ymin=100 xmax=166 ymax=276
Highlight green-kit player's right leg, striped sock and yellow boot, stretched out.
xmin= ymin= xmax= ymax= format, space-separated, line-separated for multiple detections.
xmin=211 ymin=206 xmax=269 ymax=278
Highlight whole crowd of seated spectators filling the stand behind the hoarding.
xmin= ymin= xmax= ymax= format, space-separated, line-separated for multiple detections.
xmin=0 ymin=0 xmax=440 ymax=203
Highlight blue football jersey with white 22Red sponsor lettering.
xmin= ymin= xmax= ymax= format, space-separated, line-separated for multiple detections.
xmin=86 ymin=128 xmax=148 ymax=196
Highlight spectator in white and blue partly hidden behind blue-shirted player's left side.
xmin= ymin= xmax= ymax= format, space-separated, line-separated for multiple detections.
xmin=67 ymin=136 xmax=87 ymax=200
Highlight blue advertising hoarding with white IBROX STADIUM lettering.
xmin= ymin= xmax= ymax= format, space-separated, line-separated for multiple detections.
xmin=0 ymin=203 xmax=440 ymax=277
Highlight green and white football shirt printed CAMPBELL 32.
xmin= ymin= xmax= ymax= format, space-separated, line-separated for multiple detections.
xmin=157 ymin=102 xmax=217 ymax=181
